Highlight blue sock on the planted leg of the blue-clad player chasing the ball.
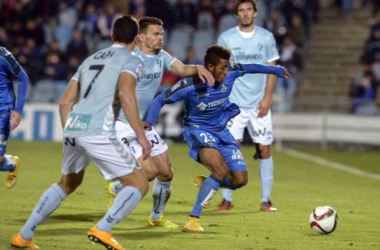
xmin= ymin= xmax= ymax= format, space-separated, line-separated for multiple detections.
xmin=190 ymin=175 xmax=221 ymax=217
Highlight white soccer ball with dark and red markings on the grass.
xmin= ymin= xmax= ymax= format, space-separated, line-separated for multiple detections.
xmin=309 ymin=206 xmax=338 ymax=234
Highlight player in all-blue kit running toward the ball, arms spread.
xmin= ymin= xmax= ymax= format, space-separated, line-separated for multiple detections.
xmin=143 ymin=45 xmax=289 ymax=231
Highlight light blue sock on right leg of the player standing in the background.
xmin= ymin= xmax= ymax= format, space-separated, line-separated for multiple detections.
xmin=259 ymin=157 xmax=273 ymax=202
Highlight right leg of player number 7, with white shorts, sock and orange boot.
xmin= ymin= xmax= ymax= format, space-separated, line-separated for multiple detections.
xmin=86 ymin=136 xmax=149 ymax=250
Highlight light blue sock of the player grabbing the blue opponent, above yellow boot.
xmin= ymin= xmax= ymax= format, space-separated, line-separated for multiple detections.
xmin=150 ymin=178 xmax=172 ymax=219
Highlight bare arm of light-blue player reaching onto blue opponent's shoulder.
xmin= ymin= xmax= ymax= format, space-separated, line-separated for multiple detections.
xmin=169 ymin=60 xmax=215 ymax=87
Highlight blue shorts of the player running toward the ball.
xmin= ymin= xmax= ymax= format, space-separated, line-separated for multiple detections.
xmin=183 ymin=128 xmax=247 ymax=171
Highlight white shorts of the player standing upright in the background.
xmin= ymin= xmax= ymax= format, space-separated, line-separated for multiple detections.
xmin=227 ymin=108 xmax=273 ymax=145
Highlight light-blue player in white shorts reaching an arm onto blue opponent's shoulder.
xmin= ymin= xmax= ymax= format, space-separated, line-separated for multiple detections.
xmin=107 ymin=17 xmax=215 ymax=228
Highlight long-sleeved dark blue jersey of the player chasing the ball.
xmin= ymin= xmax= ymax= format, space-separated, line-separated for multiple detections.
xmin=145 ymin=64 xmax=284 ymax=131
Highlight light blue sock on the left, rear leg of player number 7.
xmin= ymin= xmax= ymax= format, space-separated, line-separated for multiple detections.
xmin=20 ymin=183 xmax=67 ymax=240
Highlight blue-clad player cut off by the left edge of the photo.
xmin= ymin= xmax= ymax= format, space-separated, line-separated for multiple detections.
xmin=0 ymin=46 xmax=29 ymax=188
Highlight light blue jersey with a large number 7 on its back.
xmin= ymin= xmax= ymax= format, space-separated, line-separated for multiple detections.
xmin=64 ymin=44 xmax=143 ymax=137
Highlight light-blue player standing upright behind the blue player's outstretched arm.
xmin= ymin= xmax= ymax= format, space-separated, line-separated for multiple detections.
xmin=217 ymin=0 xmax=279 ymax=212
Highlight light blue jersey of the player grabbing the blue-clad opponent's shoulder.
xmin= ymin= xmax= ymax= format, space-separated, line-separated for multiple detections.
xmin=119 ymin=47 xmax=175 ymax=123
